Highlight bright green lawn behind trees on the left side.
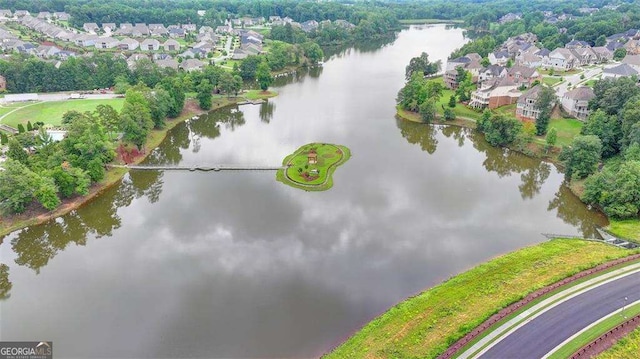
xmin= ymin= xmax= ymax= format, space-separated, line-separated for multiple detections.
xmin=0 ymin=98 xmax=124 ymax=127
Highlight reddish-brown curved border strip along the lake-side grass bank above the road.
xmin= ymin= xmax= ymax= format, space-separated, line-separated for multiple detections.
xmin=438 ymin=253 xmax=640 ymax=359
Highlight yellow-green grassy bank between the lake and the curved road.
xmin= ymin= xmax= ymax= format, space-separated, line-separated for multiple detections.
xmin=326 ymin=239 xmax=630 ymax=358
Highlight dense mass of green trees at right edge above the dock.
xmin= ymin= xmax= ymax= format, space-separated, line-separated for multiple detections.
xmin=560 ymin=78 xmax=640 ymax=218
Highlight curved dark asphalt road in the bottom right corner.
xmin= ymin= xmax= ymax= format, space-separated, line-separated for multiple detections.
xmin=480 ymin=272 xmax=640 ymax=359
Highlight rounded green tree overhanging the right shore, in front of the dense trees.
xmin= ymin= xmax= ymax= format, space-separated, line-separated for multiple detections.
xmin=559 ymin=135 xmax=602 ymax=179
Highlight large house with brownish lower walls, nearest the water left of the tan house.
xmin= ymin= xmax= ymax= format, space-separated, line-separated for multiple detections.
xmin=469 ymin=77 xmax=521 ymax=109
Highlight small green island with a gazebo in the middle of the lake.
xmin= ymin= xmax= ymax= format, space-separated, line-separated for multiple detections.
xmin=276 ymin=143 xmax=351 ymax=191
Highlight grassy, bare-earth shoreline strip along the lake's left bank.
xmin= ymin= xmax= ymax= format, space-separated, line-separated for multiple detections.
xmin=0 ymin=90 xmax=277 ymax=244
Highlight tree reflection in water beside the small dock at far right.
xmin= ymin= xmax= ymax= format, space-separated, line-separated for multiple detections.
xmin=548 ymin=184 xmax=607 ymax=238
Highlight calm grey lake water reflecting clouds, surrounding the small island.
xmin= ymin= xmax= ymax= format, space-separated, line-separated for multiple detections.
xmin=0 ymin=26 xmax=604 ymax=358
